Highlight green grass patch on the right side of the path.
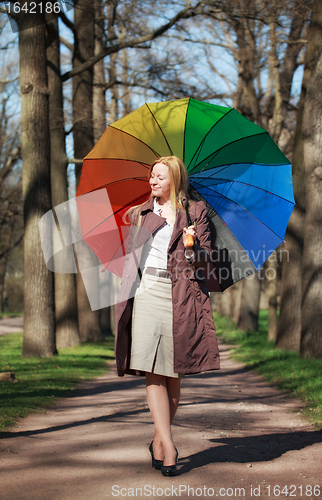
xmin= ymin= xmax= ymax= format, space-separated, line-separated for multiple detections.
xmin=214 ymin=311 xmax=322 ymax=430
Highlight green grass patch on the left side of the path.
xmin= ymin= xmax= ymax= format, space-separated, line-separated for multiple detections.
xmin=0 ymin=333 xmax=114 ymax=431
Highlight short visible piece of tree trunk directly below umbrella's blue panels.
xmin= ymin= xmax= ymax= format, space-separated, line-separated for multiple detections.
xmin=237 ymin=273 xmax=261 ymax=332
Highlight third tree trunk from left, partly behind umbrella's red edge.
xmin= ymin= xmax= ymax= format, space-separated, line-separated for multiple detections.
xmin=73 ymin=0 xmax=102 ymax=342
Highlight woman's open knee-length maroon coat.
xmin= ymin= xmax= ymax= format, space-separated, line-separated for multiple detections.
xmin=115 ymin=198 xmax=219 ymax=376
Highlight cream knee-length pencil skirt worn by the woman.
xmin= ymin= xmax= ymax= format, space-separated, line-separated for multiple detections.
xmin=130 ymin=274 xmax=182 ymax=378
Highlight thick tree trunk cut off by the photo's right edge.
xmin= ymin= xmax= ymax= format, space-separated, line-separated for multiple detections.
xmin=300 ymin=0 xmax=322 ymax=358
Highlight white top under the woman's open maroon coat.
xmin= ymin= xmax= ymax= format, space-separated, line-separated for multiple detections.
xmin=140 ymin=199 xmax=173 ymax=269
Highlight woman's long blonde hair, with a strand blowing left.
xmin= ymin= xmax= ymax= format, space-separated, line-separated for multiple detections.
xmin=123 ymin=156 xmax=189 ymax=226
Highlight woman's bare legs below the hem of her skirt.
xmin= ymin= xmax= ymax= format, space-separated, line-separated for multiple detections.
xmin=146 ymin=372 xmax=181 ymax=465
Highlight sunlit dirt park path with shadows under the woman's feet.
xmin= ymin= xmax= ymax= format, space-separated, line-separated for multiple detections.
xmin=0 ymin=344 xmax=322 ymax=500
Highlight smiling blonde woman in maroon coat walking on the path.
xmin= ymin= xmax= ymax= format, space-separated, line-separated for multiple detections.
xmin=115 ymin=156 xmax=219 ymax=476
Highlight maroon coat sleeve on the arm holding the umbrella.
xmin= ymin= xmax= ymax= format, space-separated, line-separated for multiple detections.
xmin=187 ymin=201 xmax=211 ymax=267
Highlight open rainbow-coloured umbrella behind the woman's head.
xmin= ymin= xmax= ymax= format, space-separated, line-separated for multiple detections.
xmin=76 ymin=98 xmax=294 ymax=290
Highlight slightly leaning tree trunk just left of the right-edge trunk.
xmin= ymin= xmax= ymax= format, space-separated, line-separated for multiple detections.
xmin=276 ymin=0 xmax=322 ymax=351
